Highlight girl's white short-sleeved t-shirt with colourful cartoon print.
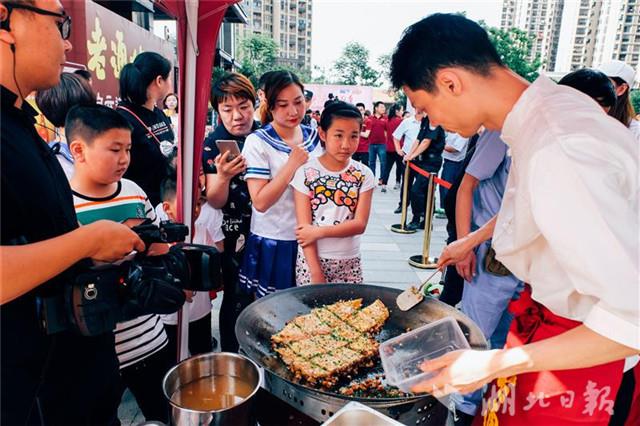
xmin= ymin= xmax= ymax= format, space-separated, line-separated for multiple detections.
xmin=291 ymin=157 xmax=375 ymax=259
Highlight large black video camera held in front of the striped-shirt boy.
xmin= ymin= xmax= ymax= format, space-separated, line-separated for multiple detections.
xmin=41 ymin=220 xmax=222 ymax=336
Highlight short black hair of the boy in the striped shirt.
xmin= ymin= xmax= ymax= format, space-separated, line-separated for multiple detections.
xmin=64 ymin=105 xmax=133 ymax=144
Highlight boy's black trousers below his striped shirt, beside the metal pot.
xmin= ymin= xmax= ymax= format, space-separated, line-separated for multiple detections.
xmin=120 ymin=345 xmax=175 ymax=423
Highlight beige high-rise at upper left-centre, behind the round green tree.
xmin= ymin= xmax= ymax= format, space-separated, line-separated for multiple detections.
xmin=236 ymin=0 xmax=313 ymax=70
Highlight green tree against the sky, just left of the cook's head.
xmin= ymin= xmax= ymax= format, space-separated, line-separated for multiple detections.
xmin=333 ymin=41 xmax=380 ymax=86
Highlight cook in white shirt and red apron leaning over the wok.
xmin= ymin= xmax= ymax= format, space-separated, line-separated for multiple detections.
xmin=390 ymin=14 xmax=640 ymax=426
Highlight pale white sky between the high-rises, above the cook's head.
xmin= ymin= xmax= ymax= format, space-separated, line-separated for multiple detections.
xmin=311 ymin=0 xmax=502 ymax=77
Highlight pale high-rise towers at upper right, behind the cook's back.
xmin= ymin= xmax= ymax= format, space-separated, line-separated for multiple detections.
xmin=501 ymin=0 xmax=640 ymax=73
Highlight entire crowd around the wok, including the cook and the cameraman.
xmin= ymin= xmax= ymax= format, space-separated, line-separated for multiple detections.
xmin=0 ymin=0 xmax=640 ymax=425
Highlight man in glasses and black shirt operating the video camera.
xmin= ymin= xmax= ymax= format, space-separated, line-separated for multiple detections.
xmin=0 ymin=0 xmax=144 ymax=424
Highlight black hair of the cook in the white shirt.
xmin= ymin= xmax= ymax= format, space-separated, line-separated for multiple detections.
xmin=389 ymin=13 xmax=504 ymax=92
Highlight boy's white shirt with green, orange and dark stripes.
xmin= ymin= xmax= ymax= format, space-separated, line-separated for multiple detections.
xmin=73 ymin=179 xmax=167 ymax=369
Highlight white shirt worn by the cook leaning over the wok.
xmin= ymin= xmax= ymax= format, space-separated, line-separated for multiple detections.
xmin=493 ymin=76 xmax=640 ymax=348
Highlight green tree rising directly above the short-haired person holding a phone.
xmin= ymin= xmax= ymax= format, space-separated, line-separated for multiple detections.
xmin=239 ymin=34 xmax=278 ymax=85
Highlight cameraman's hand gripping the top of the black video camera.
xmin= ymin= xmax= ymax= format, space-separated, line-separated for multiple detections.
xmin=83 ymin=220 xmax=144 ymax=262
